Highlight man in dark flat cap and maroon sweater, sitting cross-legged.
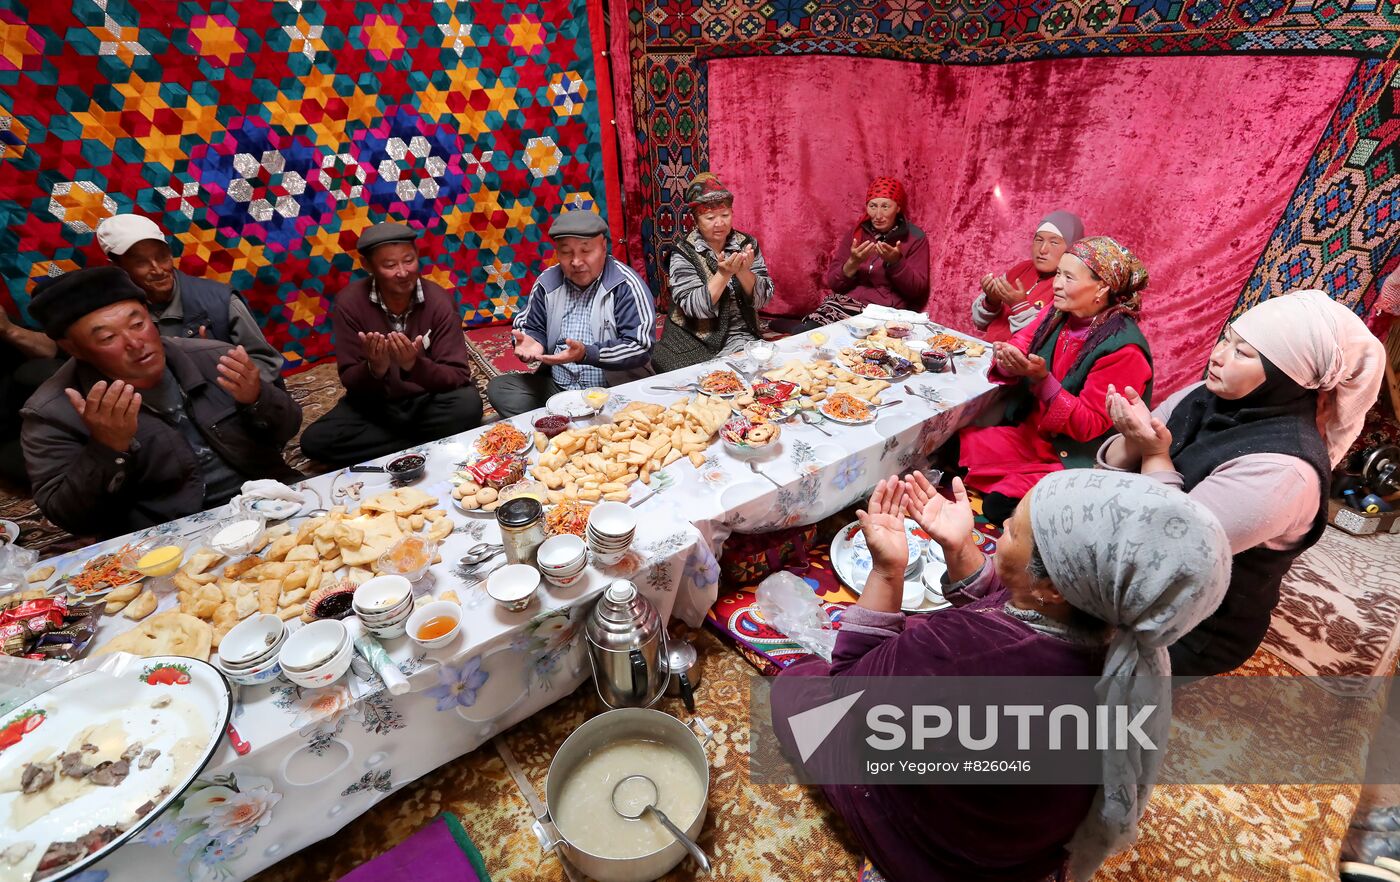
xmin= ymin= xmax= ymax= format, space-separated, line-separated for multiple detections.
xmin=301 ymin=223 xmax=482 ymax=465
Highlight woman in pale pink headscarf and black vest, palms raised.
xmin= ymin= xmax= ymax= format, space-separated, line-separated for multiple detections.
xmin=1098 ymin=291 xmax=1385 ymax=676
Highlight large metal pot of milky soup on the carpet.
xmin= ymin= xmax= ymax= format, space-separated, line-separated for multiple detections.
xmin=539 ymin=707 xmax=710 ymax=882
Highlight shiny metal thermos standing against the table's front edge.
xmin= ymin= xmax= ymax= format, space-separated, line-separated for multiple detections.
xmin=584 ymin=580 xmax=669 ymax=708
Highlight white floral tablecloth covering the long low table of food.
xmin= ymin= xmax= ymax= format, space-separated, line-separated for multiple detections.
xmin=50 ymin=325 xmax=994 ymax=882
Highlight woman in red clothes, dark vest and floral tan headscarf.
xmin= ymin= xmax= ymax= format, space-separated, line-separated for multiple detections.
xmin=959 ymin=235 xmax=1152 ymax=524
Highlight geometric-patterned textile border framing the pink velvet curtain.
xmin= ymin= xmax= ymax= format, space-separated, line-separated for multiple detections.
xmin=612 ymin=0 xmax=1400 ymax=314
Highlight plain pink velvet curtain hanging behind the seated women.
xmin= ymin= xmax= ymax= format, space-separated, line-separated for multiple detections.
xmin=708 ymin=56 xmax=1357 ymax=398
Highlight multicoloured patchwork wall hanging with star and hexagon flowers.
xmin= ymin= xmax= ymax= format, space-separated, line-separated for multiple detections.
xmin=0 ymin=0 xmax=605 ymax=370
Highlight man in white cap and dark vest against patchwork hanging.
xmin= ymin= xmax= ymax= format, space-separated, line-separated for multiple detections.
xmin=97 ymin=214 xmax=281 ymax=382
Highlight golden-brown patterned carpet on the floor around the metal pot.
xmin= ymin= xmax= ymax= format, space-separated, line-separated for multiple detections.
xmin=255 ymin=512 xmax=1394 ymax=882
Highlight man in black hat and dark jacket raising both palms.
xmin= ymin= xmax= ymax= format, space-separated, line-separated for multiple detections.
xmin=20 ymin=266 xmax=301 ymax=536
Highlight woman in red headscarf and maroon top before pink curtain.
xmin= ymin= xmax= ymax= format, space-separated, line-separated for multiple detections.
xmin=773 ymin=178 xmax=928 ymax=330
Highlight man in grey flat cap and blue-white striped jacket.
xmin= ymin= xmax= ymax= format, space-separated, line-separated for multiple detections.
xmin=486 ymin=210 xmax=657 ymax=417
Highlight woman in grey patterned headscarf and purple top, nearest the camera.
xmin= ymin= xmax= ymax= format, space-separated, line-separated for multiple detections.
xmin=773 ymin=470 xmax=1229 ymax=882
